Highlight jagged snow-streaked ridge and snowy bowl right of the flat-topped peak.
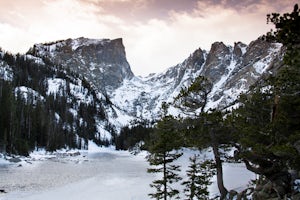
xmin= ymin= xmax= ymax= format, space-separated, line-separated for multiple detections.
xmin=110 ymin=39 xmax=282 ymax=120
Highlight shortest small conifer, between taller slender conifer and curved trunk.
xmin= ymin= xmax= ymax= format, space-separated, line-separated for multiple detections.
xmin=182 ymin=155 xmax=215 ymax=200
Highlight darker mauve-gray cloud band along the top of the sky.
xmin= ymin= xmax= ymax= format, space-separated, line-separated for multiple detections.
xmin=79 ymin=0 xmax=299 ymax=22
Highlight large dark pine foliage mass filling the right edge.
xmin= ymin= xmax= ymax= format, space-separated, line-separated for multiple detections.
xmin=234 ymin=5 xmax=300 ymax=198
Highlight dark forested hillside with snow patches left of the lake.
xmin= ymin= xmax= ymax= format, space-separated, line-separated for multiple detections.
xmin=0 ymin=52 xmax=113 ymax=155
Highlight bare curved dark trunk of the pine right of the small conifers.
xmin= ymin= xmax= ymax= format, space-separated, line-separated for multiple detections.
xmin=210 ymin=130 xmax=228 ymax=199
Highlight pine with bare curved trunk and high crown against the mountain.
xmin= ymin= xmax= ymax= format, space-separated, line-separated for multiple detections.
xmin=174 ymin=76 xmax=232 ymax=199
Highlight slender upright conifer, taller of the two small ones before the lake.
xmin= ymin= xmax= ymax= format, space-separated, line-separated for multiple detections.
xmin=148 ymin=116 xmax=182 ymax=200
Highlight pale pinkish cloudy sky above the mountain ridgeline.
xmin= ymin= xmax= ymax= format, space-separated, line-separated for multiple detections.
xmin=0 ymin=0 xmax=300 ymax=76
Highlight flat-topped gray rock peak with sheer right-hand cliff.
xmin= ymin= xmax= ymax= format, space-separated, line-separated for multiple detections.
xmin=28 ymin=38 xmax=133 ymax=93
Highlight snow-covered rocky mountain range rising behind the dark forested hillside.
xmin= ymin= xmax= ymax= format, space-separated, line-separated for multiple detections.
xmin=0 ymin=38 xmax=283 ymax=138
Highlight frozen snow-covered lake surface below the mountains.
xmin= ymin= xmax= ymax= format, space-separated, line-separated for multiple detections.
xmin=0 ymin=144 xmax=255 ymax=200
